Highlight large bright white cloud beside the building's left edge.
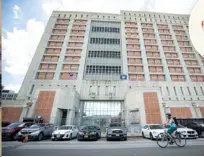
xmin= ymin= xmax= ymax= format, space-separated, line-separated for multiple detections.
xmin=2 ymin=19 xmax=44 ymax=79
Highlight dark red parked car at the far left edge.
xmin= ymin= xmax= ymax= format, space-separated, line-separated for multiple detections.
xmin=2 ymin=122 xmax=33 ymax=140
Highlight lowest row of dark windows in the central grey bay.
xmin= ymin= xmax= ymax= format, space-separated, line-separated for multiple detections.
xmin=86 ymin=65 xmax=121 ymax=74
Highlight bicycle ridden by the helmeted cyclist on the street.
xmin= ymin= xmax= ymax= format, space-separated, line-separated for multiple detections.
xmin=157 ymin=130 xmax=186 ymax=148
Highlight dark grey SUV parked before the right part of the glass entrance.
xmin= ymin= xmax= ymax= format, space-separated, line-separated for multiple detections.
xmin=106 ymin=123 xmax=127 ymax=141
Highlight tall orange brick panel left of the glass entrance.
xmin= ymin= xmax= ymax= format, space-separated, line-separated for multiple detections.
xmin=34 ymin=91 xmax=55 ymax=122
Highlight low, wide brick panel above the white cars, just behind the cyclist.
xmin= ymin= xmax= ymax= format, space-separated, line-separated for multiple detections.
xmin=170 ymin=107 xmax=192 ymax=118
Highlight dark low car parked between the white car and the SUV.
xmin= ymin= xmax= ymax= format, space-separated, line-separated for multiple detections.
xmin=77 ymin=126 xmax=101 ymax=141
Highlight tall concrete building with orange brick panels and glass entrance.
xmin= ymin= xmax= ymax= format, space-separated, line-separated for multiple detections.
xmin=2 ymin=11 xmax=204 ymax=132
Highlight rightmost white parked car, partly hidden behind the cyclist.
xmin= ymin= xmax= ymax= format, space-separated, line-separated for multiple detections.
xmin=164 ymin=124 xmax=198 ymax=138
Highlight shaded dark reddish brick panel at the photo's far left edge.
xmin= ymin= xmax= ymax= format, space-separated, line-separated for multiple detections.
xmin=2 ymin=107 xmax=23 ymax=123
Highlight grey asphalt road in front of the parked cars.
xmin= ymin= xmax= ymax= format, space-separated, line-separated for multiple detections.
xmin=2 ymin=139 xmax=204 ymax=156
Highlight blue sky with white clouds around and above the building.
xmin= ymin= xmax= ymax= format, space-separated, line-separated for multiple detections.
xmin=2 ymin=0 xmax=198 ymax=92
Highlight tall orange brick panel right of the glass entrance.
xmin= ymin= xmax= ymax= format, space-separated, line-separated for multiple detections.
xmin=144 ymin=92 xmax=162 ymax=124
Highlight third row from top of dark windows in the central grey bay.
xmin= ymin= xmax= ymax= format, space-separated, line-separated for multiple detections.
xmin=88 ymin=51 xmax=121 ymax=58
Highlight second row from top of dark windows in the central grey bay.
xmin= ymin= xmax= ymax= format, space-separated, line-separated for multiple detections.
xmin=90 ymin=38 xmax=120 ymax=45
